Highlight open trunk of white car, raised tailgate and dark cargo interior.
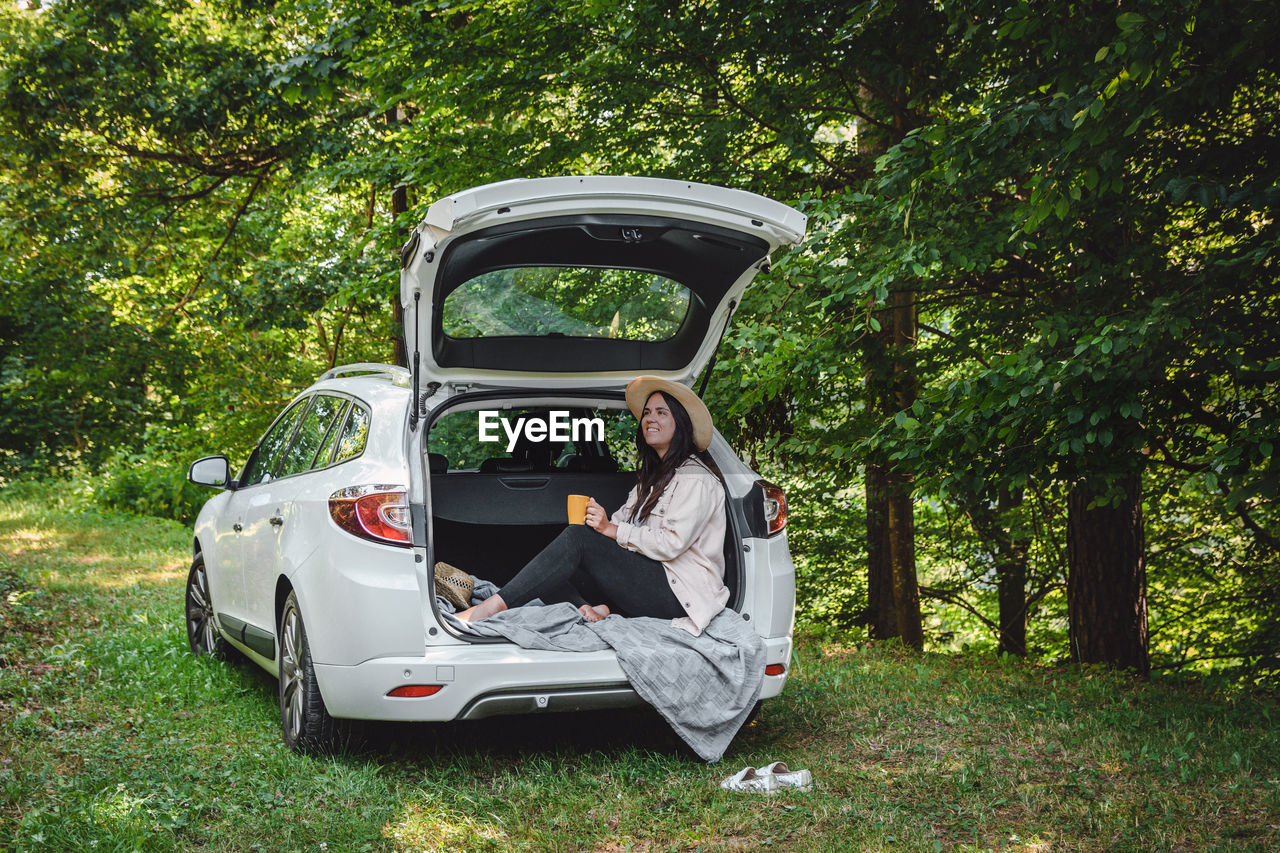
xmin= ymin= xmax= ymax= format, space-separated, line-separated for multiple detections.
xmin=401 ymin=175 xmax=806 ymax=646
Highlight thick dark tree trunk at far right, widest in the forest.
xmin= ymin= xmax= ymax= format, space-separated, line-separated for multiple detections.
xmin=1066 ymin=474 xmax=1151 ymax=675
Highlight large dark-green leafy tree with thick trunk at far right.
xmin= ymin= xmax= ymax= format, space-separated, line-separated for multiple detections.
xmin=855 ymin=4 xmax=1280 ymax=671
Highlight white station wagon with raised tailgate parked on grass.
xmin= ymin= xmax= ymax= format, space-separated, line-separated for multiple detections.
xmin=186 ymin=177 xmax=805 ymax=751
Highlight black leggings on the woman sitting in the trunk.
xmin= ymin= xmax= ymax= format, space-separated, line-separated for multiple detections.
xmin=498 ymin=524 xmax=685 ymax=619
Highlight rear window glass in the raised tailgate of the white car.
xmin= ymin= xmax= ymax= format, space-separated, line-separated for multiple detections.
xmin=440 ymin=266 xmax=690 ymax=342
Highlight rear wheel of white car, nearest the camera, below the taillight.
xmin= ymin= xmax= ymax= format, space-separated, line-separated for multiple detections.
xmin=278 ymin=592 xmax=338 ymax=754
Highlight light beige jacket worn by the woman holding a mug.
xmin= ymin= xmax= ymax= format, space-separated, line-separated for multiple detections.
xmin=609 ymin=457 xmax=728 ymax=635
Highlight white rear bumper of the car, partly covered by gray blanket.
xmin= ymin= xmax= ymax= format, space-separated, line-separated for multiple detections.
xmin=315 ymin=638 xmax=791 ymax=722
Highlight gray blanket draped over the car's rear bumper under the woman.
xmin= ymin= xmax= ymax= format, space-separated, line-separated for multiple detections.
xmin=445 ymin=601 xmax=764 ymax=762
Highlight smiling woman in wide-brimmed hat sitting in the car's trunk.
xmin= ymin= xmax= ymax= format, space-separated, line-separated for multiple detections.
xmin=457 ymin=377 xmax=728 ymax=634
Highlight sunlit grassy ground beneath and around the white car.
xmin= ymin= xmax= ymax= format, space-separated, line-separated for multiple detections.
xmin=0 ymin=488 xmax=1280 ymax=852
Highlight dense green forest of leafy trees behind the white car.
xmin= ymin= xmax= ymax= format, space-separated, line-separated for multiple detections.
xmin=0 ymin=0 xmax=1280 ymax=685
